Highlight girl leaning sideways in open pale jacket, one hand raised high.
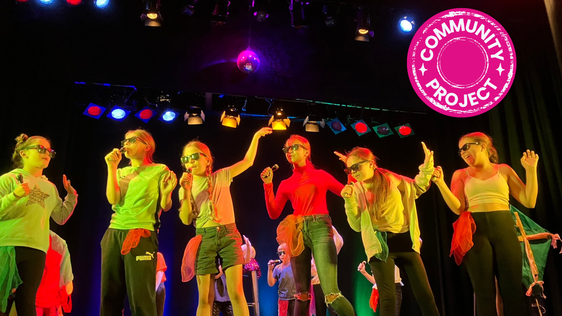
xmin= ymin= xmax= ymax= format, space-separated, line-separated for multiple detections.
xmin=341 ymin=142 xmax=439 ymax=316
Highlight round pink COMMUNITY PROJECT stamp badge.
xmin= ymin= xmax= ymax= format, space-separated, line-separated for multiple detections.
xmin=408 ymin=9 xmax=517 ymax=117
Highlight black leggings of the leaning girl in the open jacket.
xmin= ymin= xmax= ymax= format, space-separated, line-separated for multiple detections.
xmin=369 ymin=232 xmax=439 ymax=316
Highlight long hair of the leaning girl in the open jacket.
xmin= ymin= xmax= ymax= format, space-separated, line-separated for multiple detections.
xmin=347 ymin=147 xmax=391 ymax=215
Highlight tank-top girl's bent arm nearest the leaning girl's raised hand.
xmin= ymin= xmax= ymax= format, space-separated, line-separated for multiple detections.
xmin=431 ymin=166 xmax=467 ymax=215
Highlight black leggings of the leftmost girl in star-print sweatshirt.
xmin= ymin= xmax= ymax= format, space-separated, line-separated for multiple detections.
xmin=8 ymin=247 xmax=47 ymax=316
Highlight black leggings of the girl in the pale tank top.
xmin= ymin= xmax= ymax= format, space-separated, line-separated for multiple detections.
xmin=463 ymin=211 xmax=529 ymax=316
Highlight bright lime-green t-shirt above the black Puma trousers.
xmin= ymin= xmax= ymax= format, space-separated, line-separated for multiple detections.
xmin=109 ymin=164 xmax=169 ymax=231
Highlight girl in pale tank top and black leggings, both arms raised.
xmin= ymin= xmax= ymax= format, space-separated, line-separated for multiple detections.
xmin=433 ymin=132 xmax=539 ymax=315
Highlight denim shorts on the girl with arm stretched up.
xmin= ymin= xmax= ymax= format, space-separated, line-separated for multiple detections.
xmin=195 ymin=223 xmax=244 ymax=275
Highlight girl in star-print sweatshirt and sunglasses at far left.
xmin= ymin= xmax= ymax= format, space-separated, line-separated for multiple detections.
xmin=0 ymin=134 xmax=78 ymax=316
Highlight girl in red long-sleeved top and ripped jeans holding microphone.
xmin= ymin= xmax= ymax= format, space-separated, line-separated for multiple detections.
xmin=261 ymin=135 xmax=355 ymax=316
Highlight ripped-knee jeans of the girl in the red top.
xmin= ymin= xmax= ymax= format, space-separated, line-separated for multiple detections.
xmin=291 ymin=214 xmax=355 ymax=316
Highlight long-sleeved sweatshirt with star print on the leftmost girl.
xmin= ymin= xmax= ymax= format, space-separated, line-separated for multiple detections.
xmin=0 ymin=169 xmax=78 ymax=253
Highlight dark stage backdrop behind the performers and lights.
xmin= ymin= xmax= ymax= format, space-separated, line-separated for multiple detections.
xmin=0 ymin=0 xmax=562 ymax=316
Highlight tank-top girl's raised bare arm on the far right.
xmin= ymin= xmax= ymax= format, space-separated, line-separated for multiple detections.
xmin=500 ymin=149 xmax=539 ymax=208
